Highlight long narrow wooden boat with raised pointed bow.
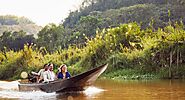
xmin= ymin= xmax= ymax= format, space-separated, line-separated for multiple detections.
xmin=18 ymin=64 xmax=108 ymax=93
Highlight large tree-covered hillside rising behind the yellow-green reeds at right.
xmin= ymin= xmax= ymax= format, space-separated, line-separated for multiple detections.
xmin=59 ymin=0 xmax=185 ymax=44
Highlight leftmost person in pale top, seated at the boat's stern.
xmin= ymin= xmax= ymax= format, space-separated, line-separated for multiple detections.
xmin=31 ymin=64 xmax=48 ymax=83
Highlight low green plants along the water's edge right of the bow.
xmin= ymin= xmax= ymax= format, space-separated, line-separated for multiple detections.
xmin=101 ymin=66 xmax=185 ymax=80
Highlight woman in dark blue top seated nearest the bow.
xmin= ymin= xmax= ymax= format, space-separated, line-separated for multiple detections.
xmin=57 ymin=64 xmax=71 ymax=79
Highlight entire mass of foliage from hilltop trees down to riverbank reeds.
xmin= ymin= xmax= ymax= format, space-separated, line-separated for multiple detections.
xmin=0 ymin=0 xmax=185 ymax=79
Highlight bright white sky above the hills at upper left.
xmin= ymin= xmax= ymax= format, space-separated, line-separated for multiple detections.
xmin=0 ymin=0 xmax=82 ymax=26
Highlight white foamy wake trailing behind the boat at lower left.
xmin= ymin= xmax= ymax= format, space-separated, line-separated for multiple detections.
xmin=0 ymin=81 xmax=56 ymax=99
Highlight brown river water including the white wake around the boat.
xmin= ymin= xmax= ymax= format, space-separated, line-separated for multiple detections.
xmin=0 ymin=80 xmax=185 ymax=100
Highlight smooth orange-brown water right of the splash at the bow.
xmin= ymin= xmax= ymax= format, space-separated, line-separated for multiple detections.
xmin=96 ymin=80 xmax=185 ymax=100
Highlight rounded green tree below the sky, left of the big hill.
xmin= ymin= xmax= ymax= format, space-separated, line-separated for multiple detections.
xmin=37 ymin=24 xmax=65 ymax=52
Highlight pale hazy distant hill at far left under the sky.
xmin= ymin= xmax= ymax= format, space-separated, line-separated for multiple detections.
xmin=0 ymin=15 xmax=42 ymax=35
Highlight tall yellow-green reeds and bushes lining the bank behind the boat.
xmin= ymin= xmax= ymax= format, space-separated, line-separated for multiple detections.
xmin=0 ymin=23 xmax=185 ymax=79
